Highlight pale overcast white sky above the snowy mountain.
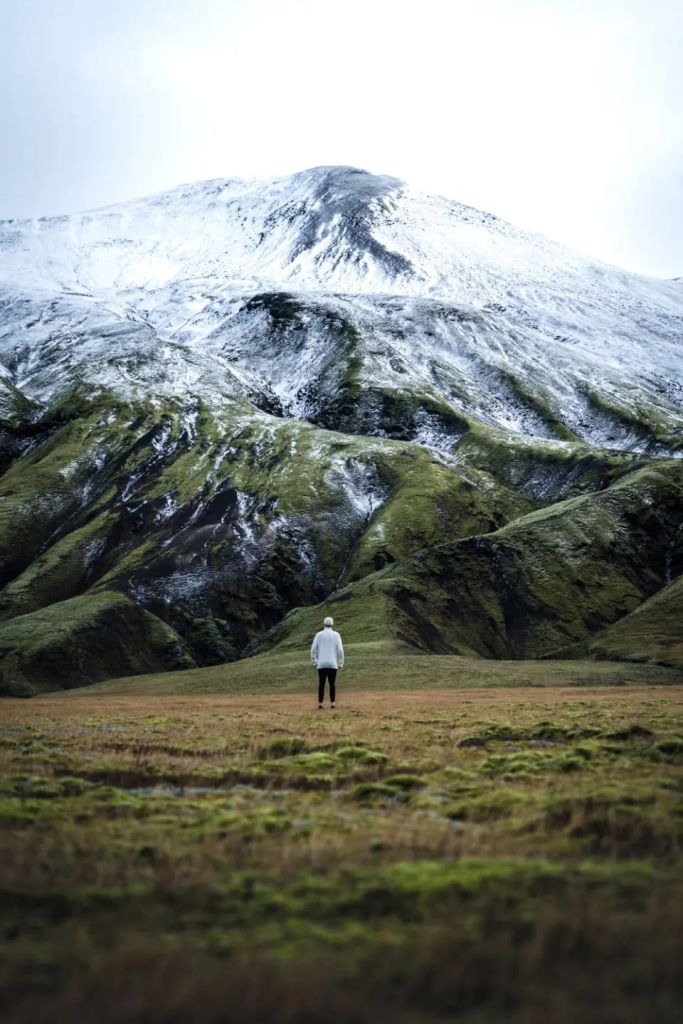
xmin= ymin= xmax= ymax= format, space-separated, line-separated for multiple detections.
xmin=0 ymin=0 xmax=683 ymax=276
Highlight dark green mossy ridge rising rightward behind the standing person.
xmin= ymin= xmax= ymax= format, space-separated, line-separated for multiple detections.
xmin=269 ymin=463 xmax=683 ymax=658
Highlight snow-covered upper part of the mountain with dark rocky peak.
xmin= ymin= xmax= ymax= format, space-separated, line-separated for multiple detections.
xmin=0 ymin=167 xmax=683 ymax=451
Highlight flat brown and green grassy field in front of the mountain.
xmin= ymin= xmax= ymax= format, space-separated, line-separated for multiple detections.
xmin=0 ymin=675 xmax=683 ymax=1024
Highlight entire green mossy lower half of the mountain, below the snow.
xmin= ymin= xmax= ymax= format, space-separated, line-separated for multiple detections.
xmin=0 ymin=386 xmax=683 ymax=693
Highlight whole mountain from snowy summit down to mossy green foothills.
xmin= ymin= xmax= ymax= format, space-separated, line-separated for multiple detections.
xmin=0 ymin=168 xmax=683 ymax=692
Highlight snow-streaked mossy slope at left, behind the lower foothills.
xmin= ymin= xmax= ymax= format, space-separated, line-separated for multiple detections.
xmin=0 ymin=391 xmax=530 ymax=685
